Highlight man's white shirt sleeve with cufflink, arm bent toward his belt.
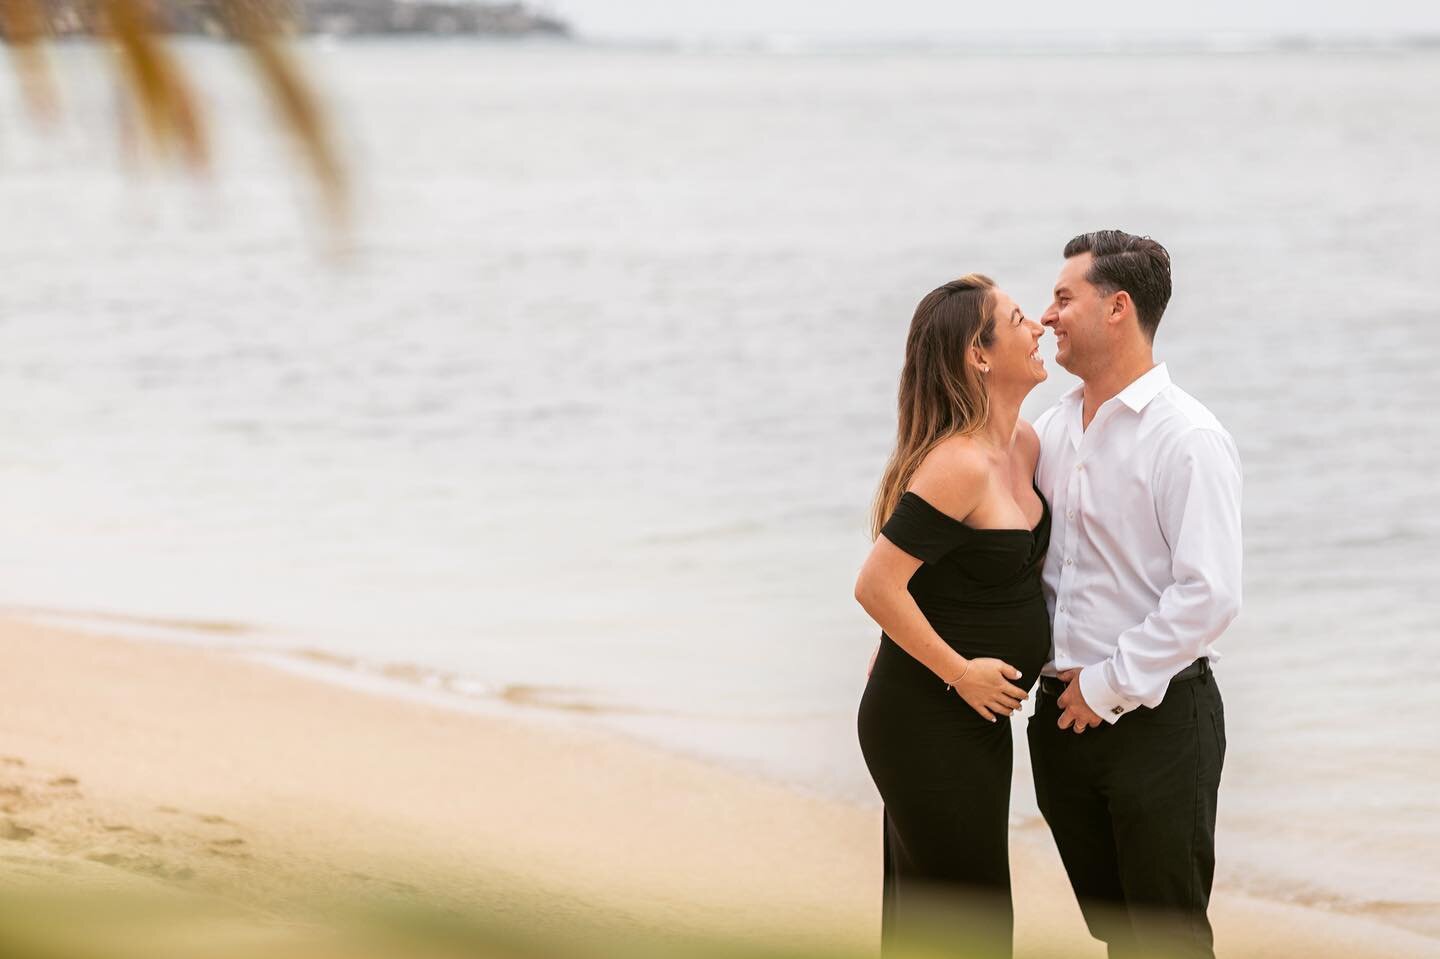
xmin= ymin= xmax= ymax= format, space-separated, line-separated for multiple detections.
xmin=1080 ymin=429 xmax=1243 ymax=723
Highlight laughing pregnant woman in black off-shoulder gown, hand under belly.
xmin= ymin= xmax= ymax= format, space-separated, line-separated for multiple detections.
xmin=855 ymin=274 xmax=1050 ymax=956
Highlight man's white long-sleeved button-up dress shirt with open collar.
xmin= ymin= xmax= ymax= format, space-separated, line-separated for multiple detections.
xmin=1035 ymin=363 xmax=1241 ymax=723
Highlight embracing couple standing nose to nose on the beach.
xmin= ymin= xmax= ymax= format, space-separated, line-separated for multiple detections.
xmin=855 ymin=230 xmax=1241 ymax=959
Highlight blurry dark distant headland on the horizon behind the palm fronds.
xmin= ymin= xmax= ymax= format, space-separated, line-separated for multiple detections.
xmin=22 ymin=0 xmax=570 ymax=39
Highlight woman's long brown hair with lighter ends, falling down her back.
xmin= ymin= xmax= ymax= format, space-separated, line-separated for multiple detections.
xmin=870 ymin=274 xmax=995 ymax=537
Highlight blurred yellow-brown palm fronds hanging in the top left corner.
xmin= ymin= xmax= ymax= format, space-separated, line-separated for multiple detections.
xmin=0 ymin=0 xmax=350 ymax=228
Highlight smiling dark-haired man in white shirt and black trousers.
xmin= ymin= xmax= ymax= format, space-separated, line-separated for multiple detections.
xmin=1028 ymin=230 xmax=1241 ymax=958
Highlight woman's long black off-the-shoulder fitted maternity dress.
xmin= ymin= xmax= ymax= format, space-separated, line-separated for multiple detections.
xmin=860 ymin=490 xmax=1050 ymax=956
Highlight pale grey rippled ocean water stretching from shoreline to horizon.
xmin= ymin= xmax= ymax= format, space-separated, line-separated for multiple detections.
xmin=0 ymin=42 xmax=1440 ymax=936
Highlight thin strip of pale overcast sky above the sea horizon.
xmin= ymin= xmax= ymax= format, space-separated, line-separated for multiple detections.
xmin=539 ymin=0 xmax=1440 ymax=40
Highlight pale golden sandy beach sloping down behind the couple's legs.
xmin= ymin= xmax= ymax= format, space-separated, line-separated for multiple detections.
xmin=0 ymin=622 xmax=1436 ymax=959
